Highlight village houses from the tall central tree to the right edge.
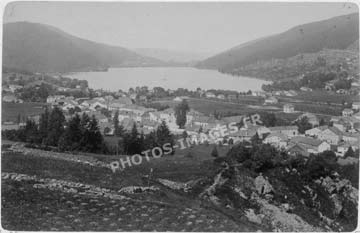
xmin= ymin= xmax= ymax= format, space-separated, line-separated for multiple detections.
xmin=180 ymin=106 xmax=360 ymax=157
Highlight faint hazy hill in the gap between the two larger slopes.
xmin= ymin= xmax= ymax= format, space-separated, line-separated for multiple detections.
xmin=134 ymin=48 xmax=212 ymax=63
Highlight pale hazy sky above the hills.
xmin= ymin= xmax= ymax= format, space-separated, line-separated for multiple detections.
xmin=4 ymin=2 xmax=358 ymax=53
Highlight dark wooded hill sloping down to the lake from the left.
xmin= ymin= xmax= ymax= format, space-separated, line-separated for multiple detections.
xmin=3 ymin=22 xmax=162 ymax=72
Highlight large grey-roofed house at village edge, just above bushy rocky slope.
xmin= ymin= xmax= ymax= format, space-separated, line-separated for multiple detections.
xmin=288 ymin=136 xmax=330 ymax=154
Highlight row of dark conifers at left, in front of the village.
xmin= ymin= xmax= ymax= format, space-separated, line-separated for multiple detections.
xmin=3 ymin=107 xmax=106 ymax=153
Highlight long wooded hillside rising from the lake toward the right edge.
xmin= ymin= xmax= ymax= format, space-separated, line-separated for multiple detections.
xmin=197 ymin=13 xmax=359 ymax=75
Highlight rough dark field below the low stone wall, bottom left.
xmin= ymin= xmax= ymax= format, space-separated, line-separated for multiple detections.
xmin=2 ymin=177 xmax=245 ymax=231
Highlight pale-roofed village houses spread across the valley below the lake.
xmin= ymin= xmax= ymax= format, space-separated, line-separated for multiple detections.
xmin=2 ymin=75 xmax=360 ymax=157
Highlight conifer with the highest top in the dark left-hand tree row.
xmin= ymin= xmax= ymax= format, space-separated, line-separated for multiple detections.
xmin=45 ymin=107 xmax=65 ymax=146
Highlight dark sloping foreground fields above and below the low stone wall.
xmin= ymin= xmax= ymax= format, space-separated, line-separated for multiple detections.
xmin=2 ymin=147 xmax=253 ymax=231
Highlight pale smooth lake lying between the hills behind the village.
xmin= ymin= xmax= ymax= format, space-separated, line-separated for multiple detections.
xmin=66 ymin=67 xmax=269 ymax=91
